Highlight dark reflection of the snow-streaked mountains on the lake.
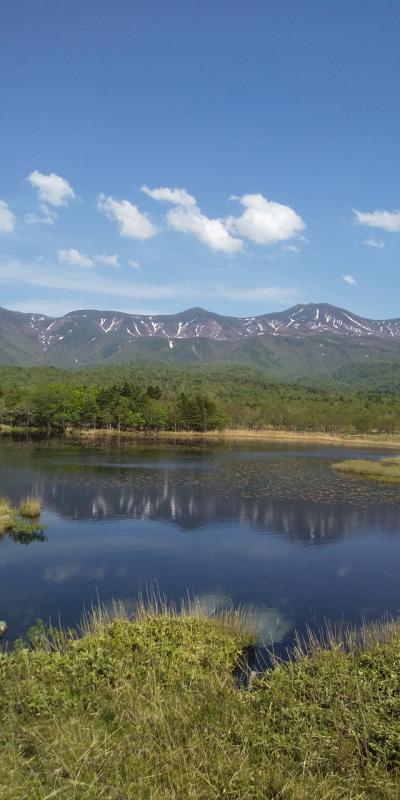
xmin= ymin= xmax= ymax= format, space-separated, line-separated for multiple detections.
xmin=4 ymin=465 xmax=400 ymax=544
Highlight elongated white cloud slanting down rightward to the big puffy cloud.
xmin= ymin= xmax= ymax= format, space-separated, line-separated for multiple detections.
xmin=142 ymin=186 xmax=243 ymax=254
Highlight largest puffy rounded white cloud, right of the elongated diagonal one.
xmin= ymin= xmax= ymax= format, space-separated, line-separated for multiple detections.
xmin=227 ymin=194 xmax=305 ymax=245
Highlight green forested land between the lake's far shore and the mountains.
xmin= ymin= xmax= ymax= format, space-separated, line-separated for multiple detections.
xmin=0 ymin=365 xmax=400 ymax=433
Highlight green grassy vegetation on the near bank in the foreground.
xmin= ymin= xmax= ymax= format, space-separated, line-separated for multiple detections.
xmin=0 ymin=592 xmax=400 ymax=800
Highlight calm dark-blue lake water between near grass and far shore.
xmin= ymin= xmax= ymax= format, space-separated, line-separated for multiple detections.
xmin=0 ymin=439 xmax=400 ymax=649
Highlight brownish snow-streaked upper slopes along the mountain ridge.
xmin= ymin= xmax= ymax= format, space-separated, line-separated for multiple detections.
xmin=0 ymin=303 xmax=400 ymax=357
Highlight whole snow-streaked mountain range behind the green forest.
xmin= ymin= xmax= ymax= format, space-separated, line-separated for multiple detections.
xmin=0 ymin=303 xmax=400 ymax=378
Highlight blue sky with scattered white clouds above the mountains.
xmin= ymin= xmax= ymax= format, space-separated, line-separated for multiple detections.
xmin=0 ymin=0 xmax=400 ymax=317
